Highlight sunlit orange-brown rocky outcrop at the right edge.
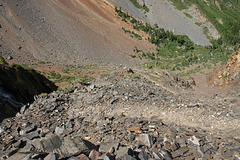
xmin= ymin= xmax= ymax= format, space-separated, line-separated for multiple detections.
xmin=209 ymin=48 xmax=240 ymax=86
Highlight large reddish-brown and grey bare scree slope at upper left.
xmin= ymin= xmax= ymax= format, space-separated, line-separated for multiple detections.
xmin=0 ymin=0 xmax=154 ymax=66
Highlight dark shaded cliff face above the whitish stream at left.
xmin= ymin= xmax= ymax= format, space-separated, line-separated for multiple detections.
xmin=0 ymin=64 xmax=57 ymax=104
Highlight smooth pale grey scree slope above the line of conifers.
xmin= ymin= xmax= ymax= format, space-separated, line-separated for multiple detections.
xmin=109 ymin=0 xmax=211 ymax=45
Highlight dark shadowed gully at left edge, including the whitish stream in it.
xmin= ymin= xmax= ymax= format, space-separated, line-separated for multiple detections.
xmin=0 ymin=64 xmax=57 ymax=121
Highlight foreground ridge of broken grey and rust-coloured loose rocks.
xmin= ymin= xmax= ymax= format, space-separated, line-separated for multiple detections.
xmin=0 ymin=70 xmax=240 ymax=160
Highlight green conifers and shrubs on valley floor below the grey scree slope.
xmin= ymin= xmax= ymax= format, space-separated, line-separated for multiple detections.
xmin=117 ymin=6 xmax=234 ymax=73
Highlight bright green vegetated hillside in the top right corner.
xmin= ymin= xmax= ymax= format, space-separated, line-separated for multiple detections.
xmin=171 ymin=0 xmax=240 ymax=46
